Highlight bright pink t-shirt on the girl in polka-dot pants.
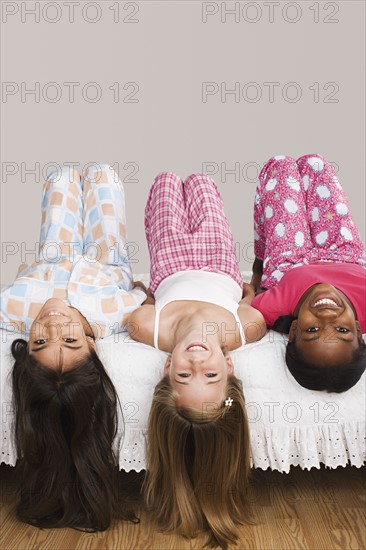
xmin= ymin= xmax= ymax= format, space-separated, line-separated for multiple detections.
xmin=252 ymin=262 xmax=366 ymax=334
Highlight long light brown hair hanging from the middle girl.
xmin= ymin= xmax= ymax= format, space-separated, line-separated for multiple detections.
xmin=144 ymin=375 xmax=250 ymax=548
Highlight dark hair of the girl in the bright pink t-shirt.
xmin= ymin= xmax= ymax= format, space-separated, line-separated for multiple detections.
xmin=273 ymin=315 xmax=366 ymax=393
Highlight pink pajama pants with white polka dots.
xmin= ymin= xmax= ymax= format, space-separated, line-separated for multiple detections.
xmin=254 ymin=155 xmax=366 ymax=289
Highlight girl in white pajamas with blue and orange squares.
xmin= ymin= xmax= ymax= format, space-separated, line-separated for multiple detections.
xmin=0 ymin=165 xmax=146 ymax=531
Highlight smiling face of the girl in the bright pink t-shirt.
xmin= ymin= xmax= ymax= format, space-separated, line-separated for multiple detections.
xmin=289 ymin=284 xmax=362 ymax=366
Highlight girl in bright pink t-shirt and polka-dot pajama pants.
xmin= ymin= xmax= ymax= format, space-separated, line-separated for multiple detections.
xmin=251 ymin=155 xmax=366 ymax=392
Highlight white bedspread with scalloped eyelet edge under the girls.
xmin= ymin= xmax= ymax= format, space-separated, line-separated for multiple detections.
xmin=0 ymin=273 xmax=366 ymax=472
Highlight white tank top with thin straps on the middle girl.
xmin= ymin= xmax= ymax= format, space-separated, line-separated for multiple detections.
xmin=154 ymin=270 xmax=245 ymax=349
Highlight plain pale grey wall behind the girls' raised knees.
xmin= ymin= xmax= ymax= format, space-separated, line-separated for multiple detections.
xmin=1 ymin=0 xmax=366 ymax=284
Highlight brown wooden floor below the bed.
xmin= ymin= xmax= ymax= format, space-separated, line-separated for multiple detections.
xmin=0 ymin=465 xmax=366 ymax=550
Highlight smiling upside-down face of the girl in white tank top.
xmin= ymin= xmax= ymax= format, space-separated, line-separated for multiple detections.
xmin=164 ymin=340 xmax=234 ymax=410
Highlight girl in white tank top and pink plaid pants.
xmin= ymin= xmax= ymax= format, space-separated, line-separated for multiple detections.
xmin=130 ymin=173 xmax=266 ymax=548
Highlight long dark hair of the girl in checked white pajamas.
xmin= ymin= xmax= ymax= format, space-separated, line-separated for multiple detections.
xmin=11 ymin=339 xmax=132 ymax=531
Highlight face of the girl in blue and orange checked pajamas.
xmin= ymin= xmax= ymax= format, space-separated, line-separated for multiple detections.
xmin=28 ymin=298 xmax=96 ymax=371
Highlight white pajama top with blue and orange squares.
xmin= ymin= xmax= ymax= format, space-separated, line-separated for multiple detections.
xmin=0 ymin=255 xmax=146 ymax=338
